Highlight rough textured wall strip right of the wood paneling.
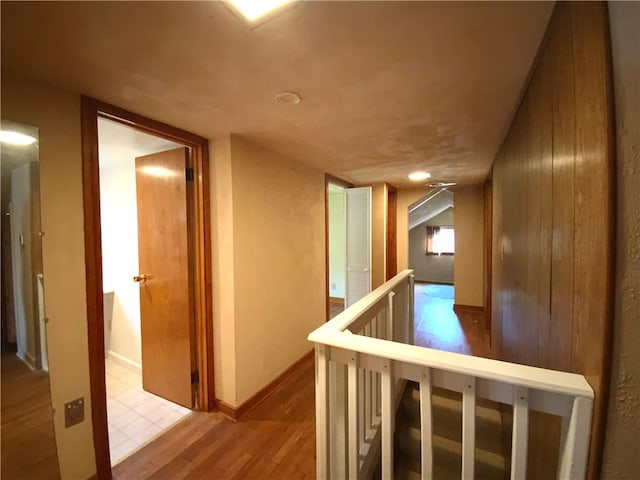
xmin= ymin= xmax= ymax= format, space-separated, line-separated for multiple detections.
xmin=602 ymin=2 xmax=640 ymax=479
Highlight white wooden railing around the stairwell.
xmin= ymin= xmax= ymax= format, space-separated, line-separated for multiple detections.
xmin=309 ymin=270 xmax=593 ymax=480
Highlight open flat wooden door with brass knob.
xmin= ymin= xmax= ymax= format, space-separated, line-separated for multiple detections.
xmin=134 ymin=147 xmax=195 ymax=408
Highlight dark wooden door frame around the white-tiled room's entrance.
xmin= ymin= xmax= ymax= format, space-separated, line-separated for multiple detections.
xmin=81 ymin=96 xmax=215 ymax=480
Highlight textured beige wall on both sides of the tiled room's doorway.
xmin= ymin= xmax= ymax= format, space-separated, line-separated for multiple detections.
xmin=2 ymin=72 xmax=325 ymax=479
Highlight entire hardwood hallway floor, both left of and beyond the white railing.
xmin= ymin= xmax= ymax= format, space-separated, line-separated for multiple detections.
xmin=113 ymin=285 xmax=489 ymax=480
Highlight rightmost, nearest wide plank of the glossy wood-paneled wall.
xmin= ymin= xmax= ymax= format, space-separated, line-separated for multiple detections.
xmin=570 ymin=3 xmax=615 ymax=472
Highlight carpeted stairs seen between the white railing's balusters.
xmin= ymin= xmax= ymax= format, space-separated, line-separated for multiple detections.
xmin=395 ymin=382 xmax=510 ymax=480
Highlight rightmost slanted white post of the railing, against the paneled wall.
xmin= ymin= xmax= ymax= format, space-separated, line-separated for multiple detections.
xmin=558 ymin=397 xmax=593 ymax=480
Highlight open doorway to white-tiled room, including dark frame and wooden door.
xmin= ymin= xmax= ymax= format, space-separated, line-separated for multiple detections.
xmin=82 ymin=97 xmax=215 ymax=479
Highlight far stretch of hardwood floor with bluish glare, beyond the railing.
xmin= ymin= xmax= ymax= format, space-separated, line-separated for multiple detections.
xmin=414 ymin=282 xmax=491 ymax=358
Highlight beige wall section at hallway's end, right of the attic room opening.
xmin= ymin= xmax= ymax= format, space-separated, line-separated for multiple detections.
xmin=453 ymin=185 xmax=484 ymax=306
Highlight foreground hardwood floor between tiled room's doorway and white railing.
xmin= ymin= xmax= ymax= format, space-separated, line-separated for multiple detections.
xmin=113 ymin=358 xmax=316 ymax=480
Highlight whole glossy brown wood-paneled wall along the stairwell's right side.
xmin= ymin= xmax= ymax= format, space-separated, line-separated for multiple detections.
xmin=492 ymin=2 xmax=615 ymax=478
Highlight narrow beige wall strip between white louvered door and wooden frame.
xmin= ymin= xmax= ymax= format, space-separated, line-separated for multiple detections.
xmin=371 ymin=183 xmax=387 ymax=290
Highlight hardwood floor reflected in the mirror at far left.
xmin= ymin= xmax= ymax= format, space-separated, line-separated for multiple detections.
xmin=0 ymin=350 xmax=60 ymax=480
